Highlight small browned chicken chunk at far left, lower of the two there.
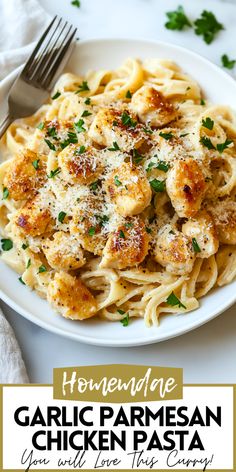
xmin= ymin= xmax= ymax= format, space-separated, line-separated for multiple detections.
xmin=15 ymin=196 xmax=53 ymax=237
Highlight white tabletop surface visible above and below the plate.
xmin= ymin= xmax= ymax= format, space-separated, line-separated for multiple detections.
xmin=2 ymin=0 xmax=236 ymax=383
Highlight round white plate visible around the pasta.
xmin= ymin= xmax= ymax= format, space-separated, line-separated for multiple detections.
xmin=0 ymin=39 xmax=236 ymax=346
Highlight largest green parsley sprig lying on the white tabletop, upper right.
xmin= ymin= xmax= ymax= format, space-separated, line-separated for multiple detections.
xmin=194 ymin=10 xmax=224 ymax=44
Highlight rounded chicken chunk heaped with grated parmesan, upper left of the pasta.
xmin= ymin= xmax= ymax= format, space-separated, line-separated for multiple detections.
xmin=58 ymin=144 xmax=103 ymax=185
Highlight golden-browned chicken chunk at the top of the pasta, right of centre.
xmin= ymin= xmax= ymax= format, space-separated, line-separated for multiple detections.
xmin=131 ymin=85 xmax=177 ymax=126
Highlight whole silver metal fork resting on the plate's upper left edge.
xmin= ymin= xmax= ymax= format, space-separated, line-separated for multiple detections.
xmin=0 ymin=16 xmax=77 ymax=138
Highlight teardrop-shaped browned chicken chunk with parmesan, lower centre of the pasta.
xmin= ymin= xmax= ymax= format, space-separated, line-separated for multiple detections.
xmin=100 ymin=218 xmax=149 ymax=269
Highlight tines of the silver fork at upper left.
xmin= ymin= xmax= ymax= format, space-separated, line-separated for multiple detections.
xmin=21 ymin=16 xmax=77 ymax=89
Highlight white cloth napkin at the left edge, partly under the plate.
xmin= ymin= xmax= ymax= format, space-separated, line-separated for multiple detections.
xmin=0 ymin=0 xmax=50 ymax=383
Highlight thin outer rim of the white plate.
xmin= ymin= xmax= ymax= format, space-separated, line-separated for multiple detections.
xmin=0 ymin=37 xmax=236 ymax=347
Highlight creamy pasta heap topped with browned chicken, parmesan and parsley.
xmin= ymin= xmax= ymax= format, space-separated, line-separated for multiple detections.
xmin=0 ymin=59 xmax=236 ymax=326
